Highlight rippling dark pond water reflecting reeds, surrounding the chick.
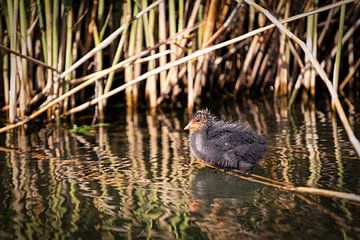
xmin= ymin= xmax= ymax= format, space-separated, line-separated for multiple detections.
xmin=0 ymin=96 xmax=360 ymax=239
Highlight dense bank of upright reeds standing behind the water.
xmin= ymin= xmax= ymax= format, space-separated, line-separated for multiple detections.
xmin=0 ymin=0 xmax=360 ymax=123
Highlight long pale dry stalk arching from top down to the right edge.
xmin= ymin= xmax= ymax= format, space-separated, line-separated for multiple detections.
xmin=244 ymin=0 xmax=360 ymax=156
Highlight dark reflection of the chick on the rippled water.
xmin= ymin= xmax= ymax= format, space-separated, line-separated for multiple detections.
xmin=189 ymin=168 xmax=261 ymax=239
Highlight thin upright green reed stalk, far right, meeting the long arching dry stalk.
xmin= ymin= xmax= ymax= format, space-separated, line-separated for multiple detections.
xmin=331 ymin=5 xmax=345 ymax=111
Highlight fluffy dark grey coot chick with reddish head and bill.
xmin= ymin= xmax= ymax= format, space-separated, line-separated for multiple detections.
xmin=184 ymin=109 xmax=266 ymax=170
